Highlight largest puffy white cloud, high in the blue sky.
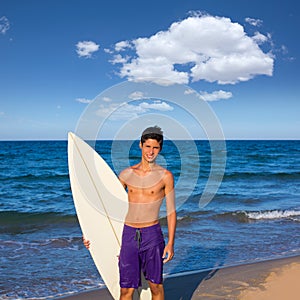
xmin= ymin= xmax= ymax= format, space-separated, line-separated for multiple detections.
xmin=113 ymin=14 xmax=274 ymax=85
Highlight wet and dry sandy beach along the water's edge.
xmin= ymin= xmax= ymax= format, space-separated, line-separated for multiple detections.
xmin=57 ymin=256 xmax=300 ymax=300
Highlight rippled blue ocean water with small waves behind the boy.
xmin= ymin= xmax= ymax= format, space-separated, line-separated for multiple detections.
xmin=0 ymin=141 xmax=300 ymax=299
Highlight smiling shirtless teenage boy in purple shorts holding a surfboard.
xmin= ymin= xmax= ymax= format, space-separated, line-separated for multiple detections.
xmin=84 ymin=126 xmax=176 ymax=300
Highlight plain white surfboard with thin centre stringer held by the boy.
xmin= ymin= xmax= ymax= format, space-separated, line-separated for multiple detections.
xmin=68 ymin=132 xmax=151 ymax=300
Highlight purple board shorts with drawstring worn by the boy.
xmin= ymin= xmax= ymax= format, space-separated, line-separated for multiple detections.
xmin=119 ymin=224 xmax=165 ymax=288
